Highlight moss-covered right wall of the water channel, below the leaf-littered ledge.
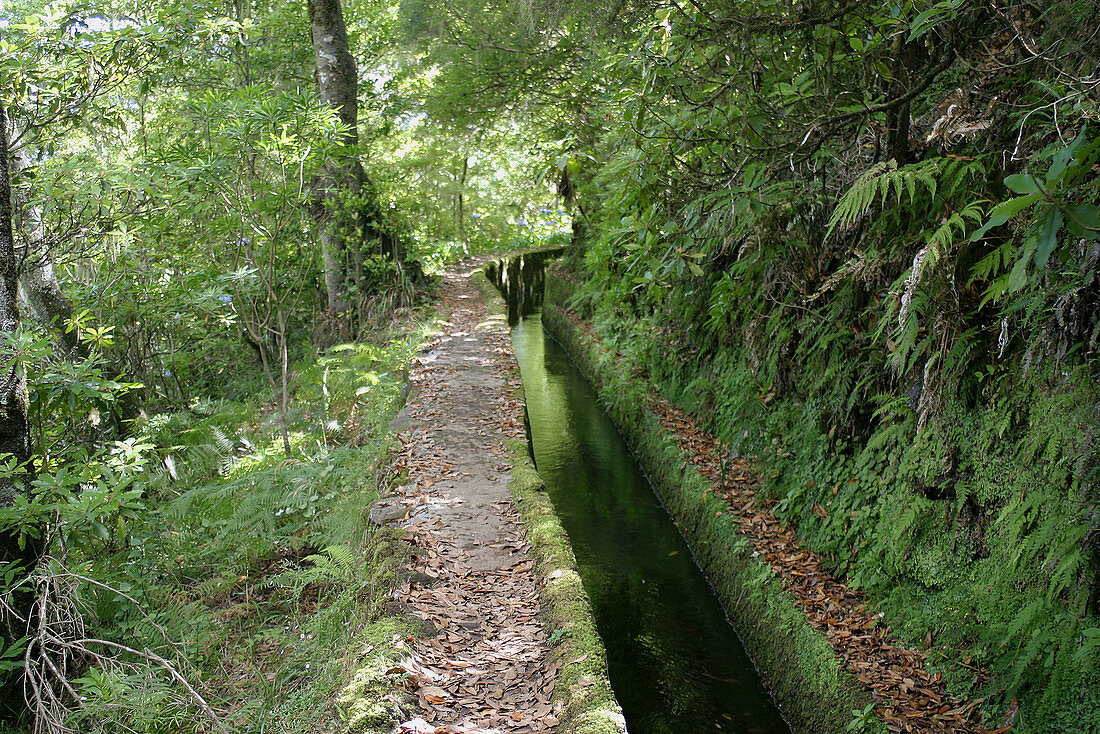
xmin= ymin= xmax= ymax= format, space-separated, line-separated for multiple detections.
xmin=542 ymin=270 xmax=886 ymax=734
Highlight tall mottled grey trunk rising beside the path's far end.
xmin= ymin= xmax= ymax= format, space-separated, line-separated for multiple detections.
xmin=309 ymin=0 xmax=363 ymax=313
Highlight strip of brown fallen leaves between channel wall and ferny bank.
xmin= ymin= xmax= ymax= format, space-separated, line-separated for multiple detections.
xmin=565 ymin=311 xmax=1011 ymax=734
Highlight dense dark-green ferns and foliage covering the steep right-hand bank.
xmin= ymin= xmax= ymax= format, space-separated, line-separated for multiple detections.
xmin=545 ymin=1 xmax=1100 ymax=731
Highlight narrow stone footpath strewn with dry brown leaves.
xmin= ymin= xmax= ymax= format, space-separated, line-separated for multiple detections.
xmin=372 ymin=260 xmax=558 ymax=734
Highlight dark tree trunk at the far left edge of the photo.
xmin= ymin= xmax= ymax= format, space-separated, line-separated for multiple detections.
xmin=0 ymin=99 xmax=42 ymax=721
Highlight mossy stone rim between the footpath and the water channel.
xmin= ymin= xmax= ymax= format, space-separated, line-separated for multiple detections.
xmin=471 ymin=260 xmax=626 ymax=734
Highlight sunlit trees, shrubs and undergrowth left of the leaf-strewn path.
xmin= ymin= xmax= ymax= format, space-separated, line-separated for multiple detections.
xmin=0 ymin=0 xmax=568 ymax=732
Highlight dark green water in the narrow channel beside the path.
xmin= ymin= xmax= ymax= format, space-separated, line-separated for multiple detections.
xmin=490 ymin=254 xmax=790 ymax=734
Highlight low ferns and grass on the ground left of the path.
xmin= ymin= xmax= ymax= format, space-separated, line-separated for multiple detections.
xmin=49 ymin=332 xmax=422 ymax=734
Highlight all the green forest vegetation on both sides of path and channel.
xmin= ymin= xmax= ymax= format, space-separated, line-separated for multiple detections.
xmin=0 ymin=0 xmax=1100 ymax=732
